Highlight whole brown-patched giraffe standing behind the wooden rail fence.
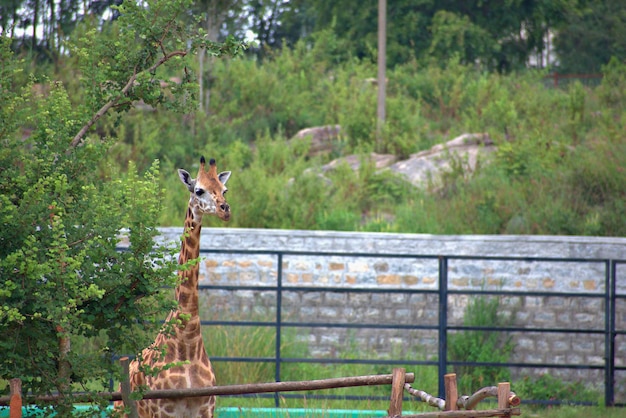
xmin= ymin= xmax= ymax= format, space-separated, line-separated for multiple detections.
xmin=116 ymin=156 xmax=231 ymax=418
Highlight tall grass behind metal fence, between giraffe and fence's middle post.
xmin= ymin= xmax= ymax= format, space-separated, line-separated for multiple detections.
xmin=204 ymin=326 xmax=437 ymax=411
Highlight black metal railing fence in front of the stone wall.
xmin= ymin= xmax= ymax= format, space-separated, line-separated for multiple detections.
xmin=200 ymin=250 xmax=626 ymax=407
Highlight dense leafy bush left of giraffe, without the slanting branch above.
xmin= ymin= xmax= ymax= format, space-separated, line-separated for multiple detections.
xmin=0 ymin=75 xmax=178 ymax=404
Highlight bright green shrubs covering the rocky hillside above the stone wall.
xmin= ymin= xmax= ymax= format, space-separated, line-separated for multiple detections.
xmin=128 ymin=47 xmax=626 ymax=236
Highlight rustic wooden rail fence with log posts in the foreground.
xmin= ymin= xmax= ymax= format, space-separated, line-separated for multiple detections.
xmin=0 ymin=370 xmax=521 ymax=418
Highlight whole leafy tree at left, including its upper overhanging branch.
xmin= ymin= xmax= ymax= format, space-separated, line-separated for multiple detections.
xmin=0 ymin=0 xmax=243 ymax=408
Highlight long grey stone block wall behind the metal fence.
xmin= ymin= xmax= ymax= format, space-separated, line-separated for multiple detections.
xmin=128 ymin=228 xmax=626 ymax=394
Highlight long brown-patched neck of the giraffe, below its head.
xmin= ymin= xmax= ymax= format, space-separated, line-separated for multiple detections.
xmin=176 ymin=206 xmax=202 ymax=320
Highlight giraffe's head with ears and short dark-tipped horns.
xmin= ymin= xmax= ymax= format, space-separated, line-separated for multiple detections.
xmin=178 ymin=156 xmax=230 ymax=221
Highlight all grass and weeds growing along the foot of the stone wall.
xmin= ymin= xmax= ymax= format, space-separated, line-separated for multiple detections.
xmin=203 ymin=306 xmax=608 ymax=417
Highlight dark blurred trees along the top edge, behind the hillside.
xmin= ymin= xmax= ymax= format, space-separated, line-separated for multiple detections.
xmin=0 ymin=0 xmax=626 ymax=72
